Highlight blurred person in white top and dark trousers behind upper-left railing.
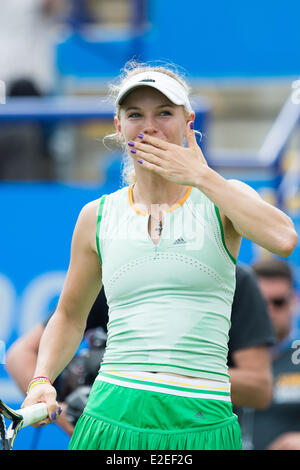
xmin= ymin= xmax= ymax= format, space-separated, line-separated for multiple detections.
xmin=0 ymin=0 xmax=66 ymax=181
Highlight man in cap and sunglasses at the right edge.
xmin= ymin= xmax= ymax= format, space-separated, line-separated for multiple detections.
xmin=240 ymin=258 xmax=300 ymax=450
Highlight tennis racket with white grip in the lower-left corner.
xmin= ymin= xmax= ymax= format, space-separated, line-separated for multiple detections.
xmin=0 ymin=400 xmax=48 ymax=450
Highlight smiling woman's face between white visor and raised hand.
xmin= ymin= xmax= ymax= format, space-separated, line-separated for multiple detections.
xmin=115 ymin=87 xmax=194 ymax=145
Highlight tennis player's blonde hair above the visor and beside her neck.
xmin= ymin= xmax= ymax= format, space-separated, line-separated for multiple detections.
xmin=103 ymin=60 xmax=190 ymax=185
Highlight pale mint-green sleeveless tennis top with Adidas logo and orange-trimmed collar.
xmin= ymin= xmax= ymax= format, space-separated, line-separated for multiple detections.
xmin=96 ymin=186 xmax=236 ymax=382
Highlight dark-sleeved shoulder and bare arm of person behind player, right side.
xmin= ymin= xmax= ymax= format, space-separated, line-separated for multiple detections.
xmin=228 ymin=263 xmax=275 ymax=410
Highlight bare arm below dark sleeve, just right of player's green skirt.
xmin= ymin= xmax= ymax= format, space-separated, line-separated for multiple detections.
xmin=229 ymin=346 xmax=273 ymax=409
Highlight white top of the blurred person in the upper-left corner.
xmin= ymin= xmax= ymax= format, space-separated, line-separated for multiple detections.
xmin=0 ymin=0 xmax=62 ymax=95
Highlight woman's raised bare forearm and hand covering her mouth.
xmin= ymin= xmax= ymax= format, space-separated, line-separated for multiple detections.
xmin=129 ymin=123 xmax=298 ymax=256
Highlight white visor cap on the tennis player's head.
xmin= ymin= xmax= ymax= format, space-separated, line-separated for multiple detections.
xmin=116 ymin=71 xmax=192 ymax=112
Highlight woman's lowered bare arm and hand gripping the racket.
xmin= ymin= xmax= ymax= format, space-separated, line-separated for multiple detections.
xmin=23 ymin=201 xmax=101 ymax=416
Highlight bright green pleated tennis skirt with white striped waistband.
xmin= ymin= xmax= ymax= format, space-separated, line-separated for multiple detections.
xmin=69 ymin=371 xmax=242 ymax=450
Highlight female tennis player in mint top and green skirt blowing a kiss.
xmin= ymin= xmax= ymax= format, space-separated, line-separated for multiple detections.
xmin=23 ymin=60 xmax=297 ymax=450
